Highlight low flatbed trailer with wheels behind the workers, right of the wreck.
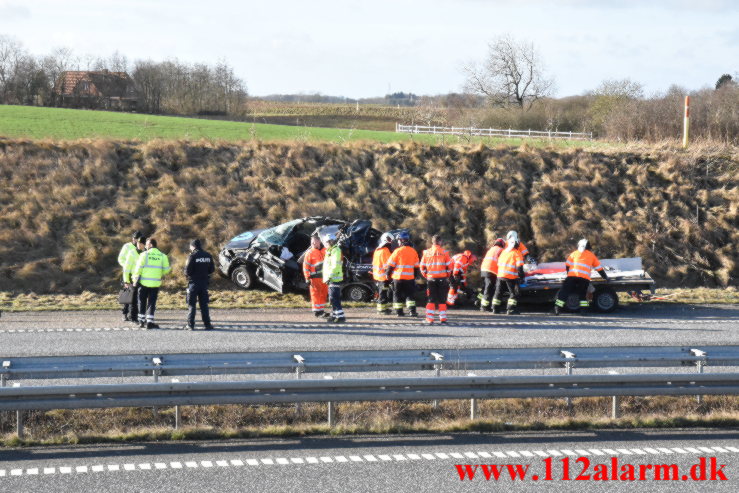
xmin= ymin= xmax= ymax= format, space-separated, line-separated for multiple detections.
xmin=520 ymin=257 xmax=655 ymax=313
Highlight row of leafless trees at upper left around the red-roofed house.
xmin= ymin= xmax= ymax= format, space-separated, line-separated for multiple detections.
xmin=0 ymin=35 xmax=247 ymax=119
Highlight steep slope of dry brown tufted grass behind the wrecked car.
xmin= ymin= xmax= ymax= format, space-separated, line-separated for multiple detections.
xmin=0 ymin=139 xmax=739 ymax=294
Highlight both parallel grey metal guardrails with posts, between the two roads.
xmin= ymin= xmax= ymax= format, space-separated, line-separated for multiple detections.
xmin=0 ymin=346 xmax=739 ymax=436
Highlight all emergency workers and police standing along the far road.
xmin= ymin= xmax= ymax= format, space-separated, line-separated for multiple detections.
xmin=118 ymin=225 xmax=608 ymax=330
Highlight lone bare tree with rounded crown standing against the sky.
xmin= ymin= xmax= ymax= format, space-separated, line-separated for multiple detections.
xmin=464 ymin=36 xmax=554 ymax=109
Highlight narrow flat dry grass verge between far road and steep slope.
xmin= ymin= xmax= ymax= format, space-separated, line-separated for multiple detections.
xmin=0 ymin=286 xmax=739 ymax=312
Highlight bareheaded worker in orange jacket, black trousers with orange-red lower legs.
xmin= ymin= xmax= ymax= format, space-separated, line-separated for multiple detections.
xmin=419 ymin=235 xmax=452 ymax=324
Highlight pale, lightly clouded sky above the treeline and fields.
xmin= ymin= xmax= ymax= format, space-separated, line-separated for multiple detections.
xmin=0 ymin=0 xmax=739 ymax=97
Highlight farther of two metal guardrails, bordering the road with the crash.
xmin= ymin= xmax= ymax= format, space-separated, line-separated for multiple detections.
xmin=0 ymin=346 xmax=739 ymax=386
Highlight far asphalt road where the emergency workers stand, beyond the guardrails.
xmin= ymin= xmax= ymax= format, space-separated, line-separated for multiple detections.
xmin=0 ymin=304 xmax=739 ymax=356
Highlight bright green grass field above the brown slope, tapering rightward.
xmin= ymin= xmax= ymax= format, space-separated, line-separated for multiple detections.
xmin=0 ymin=105 xmax=598 ymax=147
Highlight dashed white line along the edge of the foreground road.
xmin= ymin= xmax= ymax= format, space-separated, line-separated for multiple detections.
xmin=0 ymin=446 xmax=739 ymax=478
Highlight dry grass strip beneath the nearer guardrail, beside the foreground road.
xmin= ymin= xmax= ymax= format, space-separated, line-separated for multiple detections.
xmin=0 ymin=396 xmax=739 ymax=446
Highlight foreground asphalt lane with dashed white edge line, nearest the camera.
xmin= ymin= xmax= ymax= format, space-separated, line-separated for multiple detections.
xmin=0 ymin=430 xmax=739 ymax=493
